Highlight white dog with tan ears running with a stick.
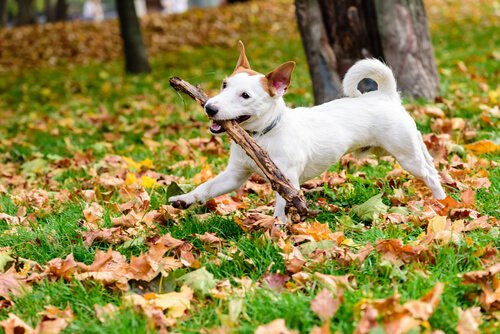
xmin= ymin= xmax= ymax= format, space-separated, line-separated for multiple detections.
xmin=169 ymin=41 xmax=446 ymax=221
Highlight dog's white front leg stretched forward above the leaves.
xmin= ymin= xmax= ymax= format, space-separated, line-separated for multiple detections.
xmin=168 ymin=166 xmax=250 ymax=209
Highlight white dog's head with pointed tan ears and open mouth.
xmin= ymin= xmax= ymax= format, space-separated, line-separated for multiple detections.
xmin=205 ymin=41 xmax=295 ymax=134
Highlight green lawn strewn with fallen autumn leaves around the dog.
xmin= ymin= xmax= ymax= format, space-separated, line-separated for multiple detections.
xmin=0 ymin=0 xmax=500 ymax=333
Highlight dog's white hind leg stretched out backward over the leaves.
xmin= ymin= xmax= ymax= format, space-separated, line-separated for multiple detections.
xmin=384 ymin=133 xmax=446 ymax=199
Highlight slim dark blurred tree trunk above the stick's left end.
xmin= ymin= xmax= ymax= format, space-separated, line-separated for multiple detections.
xmin=116 ymin=0 xmax=151 ymax=74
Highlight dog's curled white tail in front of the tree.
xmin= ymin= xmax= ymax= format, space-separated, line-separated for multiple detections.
xmin=342 ymin=59 xmax=399 ymax=99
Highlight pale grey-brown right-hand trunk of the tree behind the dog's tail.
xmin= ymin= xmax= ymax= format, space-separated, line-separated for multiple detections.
xmin=376 ymin=0 xmax=439 ymax=99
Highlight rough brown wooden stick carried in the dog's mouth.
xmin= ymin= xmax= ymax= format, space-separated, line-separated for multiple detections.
xmin=170 ymin=77 xmax=309 ymax=222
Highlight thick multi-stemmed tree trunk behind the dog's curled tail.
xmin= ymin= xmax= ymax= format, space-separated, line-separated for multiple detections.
xmin=295 ymin=0 xmax=439 ymax=104
